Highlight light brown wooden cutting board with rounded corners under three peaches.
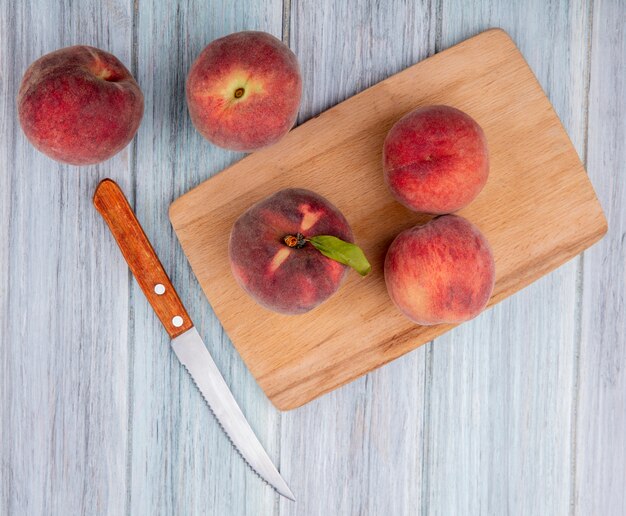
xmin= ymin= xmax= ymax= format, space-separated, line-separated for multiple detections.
xmin=170 ymin=29 xmax=607 ymax=410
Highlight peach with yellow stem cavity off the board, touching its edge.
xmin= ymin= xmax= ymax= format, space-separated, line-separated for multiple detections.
xmin=186 ymin=31 xmax=302 ymax=152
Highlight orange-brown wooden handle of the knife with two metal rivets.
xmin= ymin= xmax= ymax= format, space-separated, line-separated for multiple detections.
xmin=93 ymin=179 xmax=193 ymax=338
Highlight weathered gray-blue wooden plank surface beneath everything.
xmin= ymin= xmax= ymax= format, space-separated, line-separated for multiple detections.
xmin=0 ymin=0 xmax=626 ymax=516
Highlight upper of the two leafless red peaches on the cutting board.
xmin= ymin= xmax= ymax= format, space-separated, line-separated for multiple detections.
xmin=383 ymin=106 xmax=489 ymax=214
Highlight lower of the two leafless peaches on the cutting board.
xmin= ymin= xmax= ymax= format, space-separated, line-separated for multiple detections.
xmin=385 ymin=215 xmax=495 ymax=325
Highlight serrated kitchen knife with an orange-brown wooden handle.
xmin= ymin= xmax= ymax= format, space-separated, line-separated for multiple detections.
xmin=93 ymin=179 xmax=295 ymax=500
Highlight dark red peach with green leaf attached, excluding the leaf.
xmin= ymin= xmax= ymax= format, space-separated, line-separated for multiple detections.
xmin=229 ymin=188 xmax=353 ymax=314
